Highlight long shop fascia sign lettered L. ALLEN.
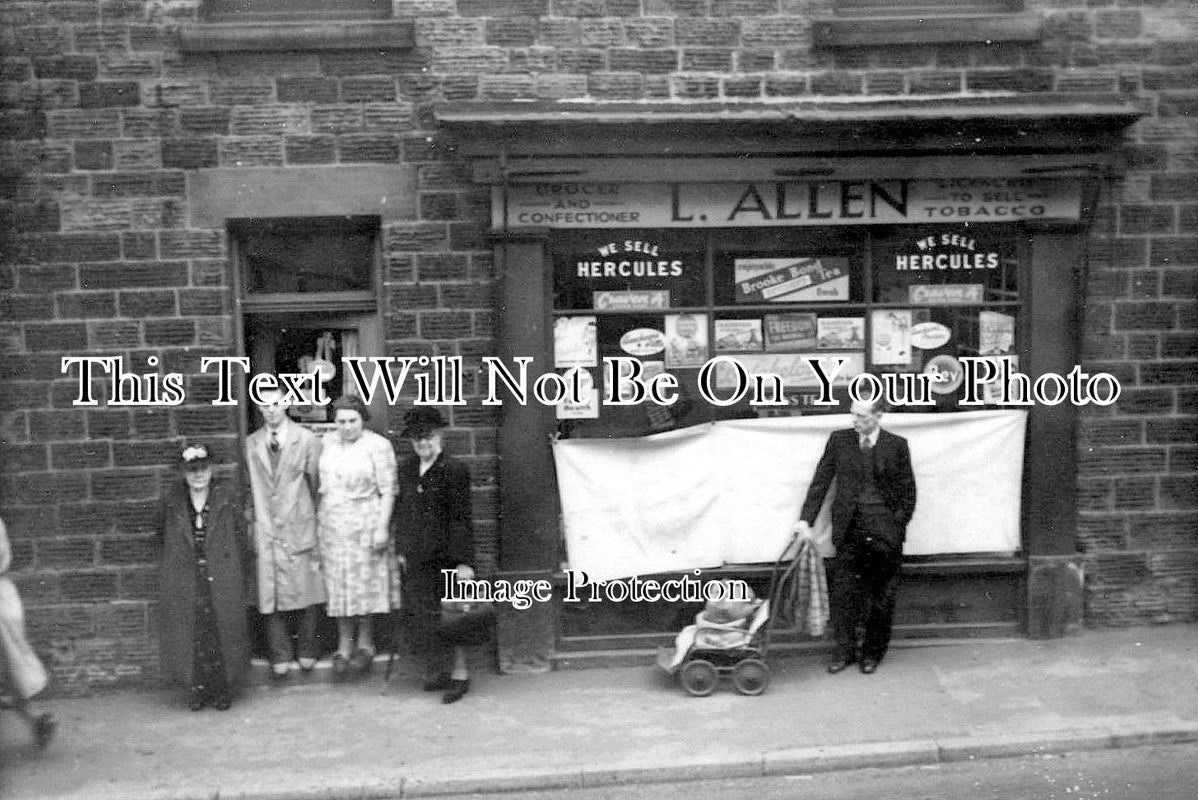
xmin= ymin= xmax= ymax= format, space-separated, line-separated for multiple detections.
xmin=495 ymin=178 xmax=1081 ymax=229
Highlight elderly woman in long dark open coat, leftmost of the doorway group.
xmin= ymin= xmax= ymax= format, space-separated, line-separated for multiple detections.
xmin=158 ymin=446 xmax=250 ymax=711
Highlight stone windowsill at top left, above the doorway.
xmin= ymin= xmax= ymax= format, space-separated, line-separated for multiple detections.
xmin=180 ymin=19 xmax=416 ymax=53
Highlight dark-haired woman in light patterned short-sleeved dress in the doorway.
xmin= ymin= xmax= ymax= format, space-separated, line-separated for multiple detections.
xmin=317 ymin=396 xmax=399 ymax=675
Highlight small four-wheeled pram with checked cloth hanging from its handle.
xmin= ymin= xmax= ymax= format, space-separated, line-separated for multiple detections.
xmin=658 ymin=532 xmax=827 ymax=697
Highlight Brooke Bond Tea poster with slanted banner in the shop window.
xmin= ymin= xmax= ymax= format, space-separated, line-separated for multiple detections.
xmin=733 ymin=257 xmax=848 ymax=303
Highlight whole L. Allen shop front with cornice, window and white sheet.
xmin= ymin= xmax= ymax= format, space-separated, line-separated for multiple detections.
xmin=438 ymin=99 xmax=1135 ymax=669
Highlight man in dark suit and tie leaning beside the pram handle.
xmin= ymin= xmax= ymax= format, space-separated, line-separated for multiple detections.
xmin=798 ymin=402 xmax=915 ymax=674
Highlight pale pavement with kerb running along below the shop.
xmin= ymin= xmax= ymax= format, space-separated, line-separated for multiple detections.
xmin=0 ymin=625 xmax=1198 ymax=800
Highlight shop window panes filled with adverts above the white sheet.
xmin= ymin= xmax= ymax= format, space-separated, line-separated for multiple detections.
xmin=551 ymin=224 xmax=1025 ymax=436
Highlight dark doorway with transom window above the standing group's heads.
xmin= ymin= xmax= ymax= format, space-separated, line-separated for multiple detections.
xmin=230 ymin=217 xmax=386 ymax=428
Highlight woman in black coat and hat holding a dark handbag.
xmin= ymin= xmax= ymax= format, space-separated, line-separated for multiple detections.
xmin=395 ymin=406 xmax=474 ymax=703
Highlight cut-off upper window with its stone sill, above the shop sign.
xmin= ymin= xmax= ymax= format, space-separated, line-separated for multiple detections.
xmin=813 ymin=0 xmax=1041 ymax=47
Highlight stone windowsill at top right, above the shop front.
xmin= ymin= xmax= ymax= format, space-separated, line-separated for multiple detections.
xmin=812 ymin=13 xmax=1042 ymax=47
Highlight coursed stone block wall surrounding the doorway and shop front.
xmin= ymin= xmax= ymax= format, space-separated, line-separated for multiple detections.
xmin=0 ymin=0 xmax=1198 ymax=691
